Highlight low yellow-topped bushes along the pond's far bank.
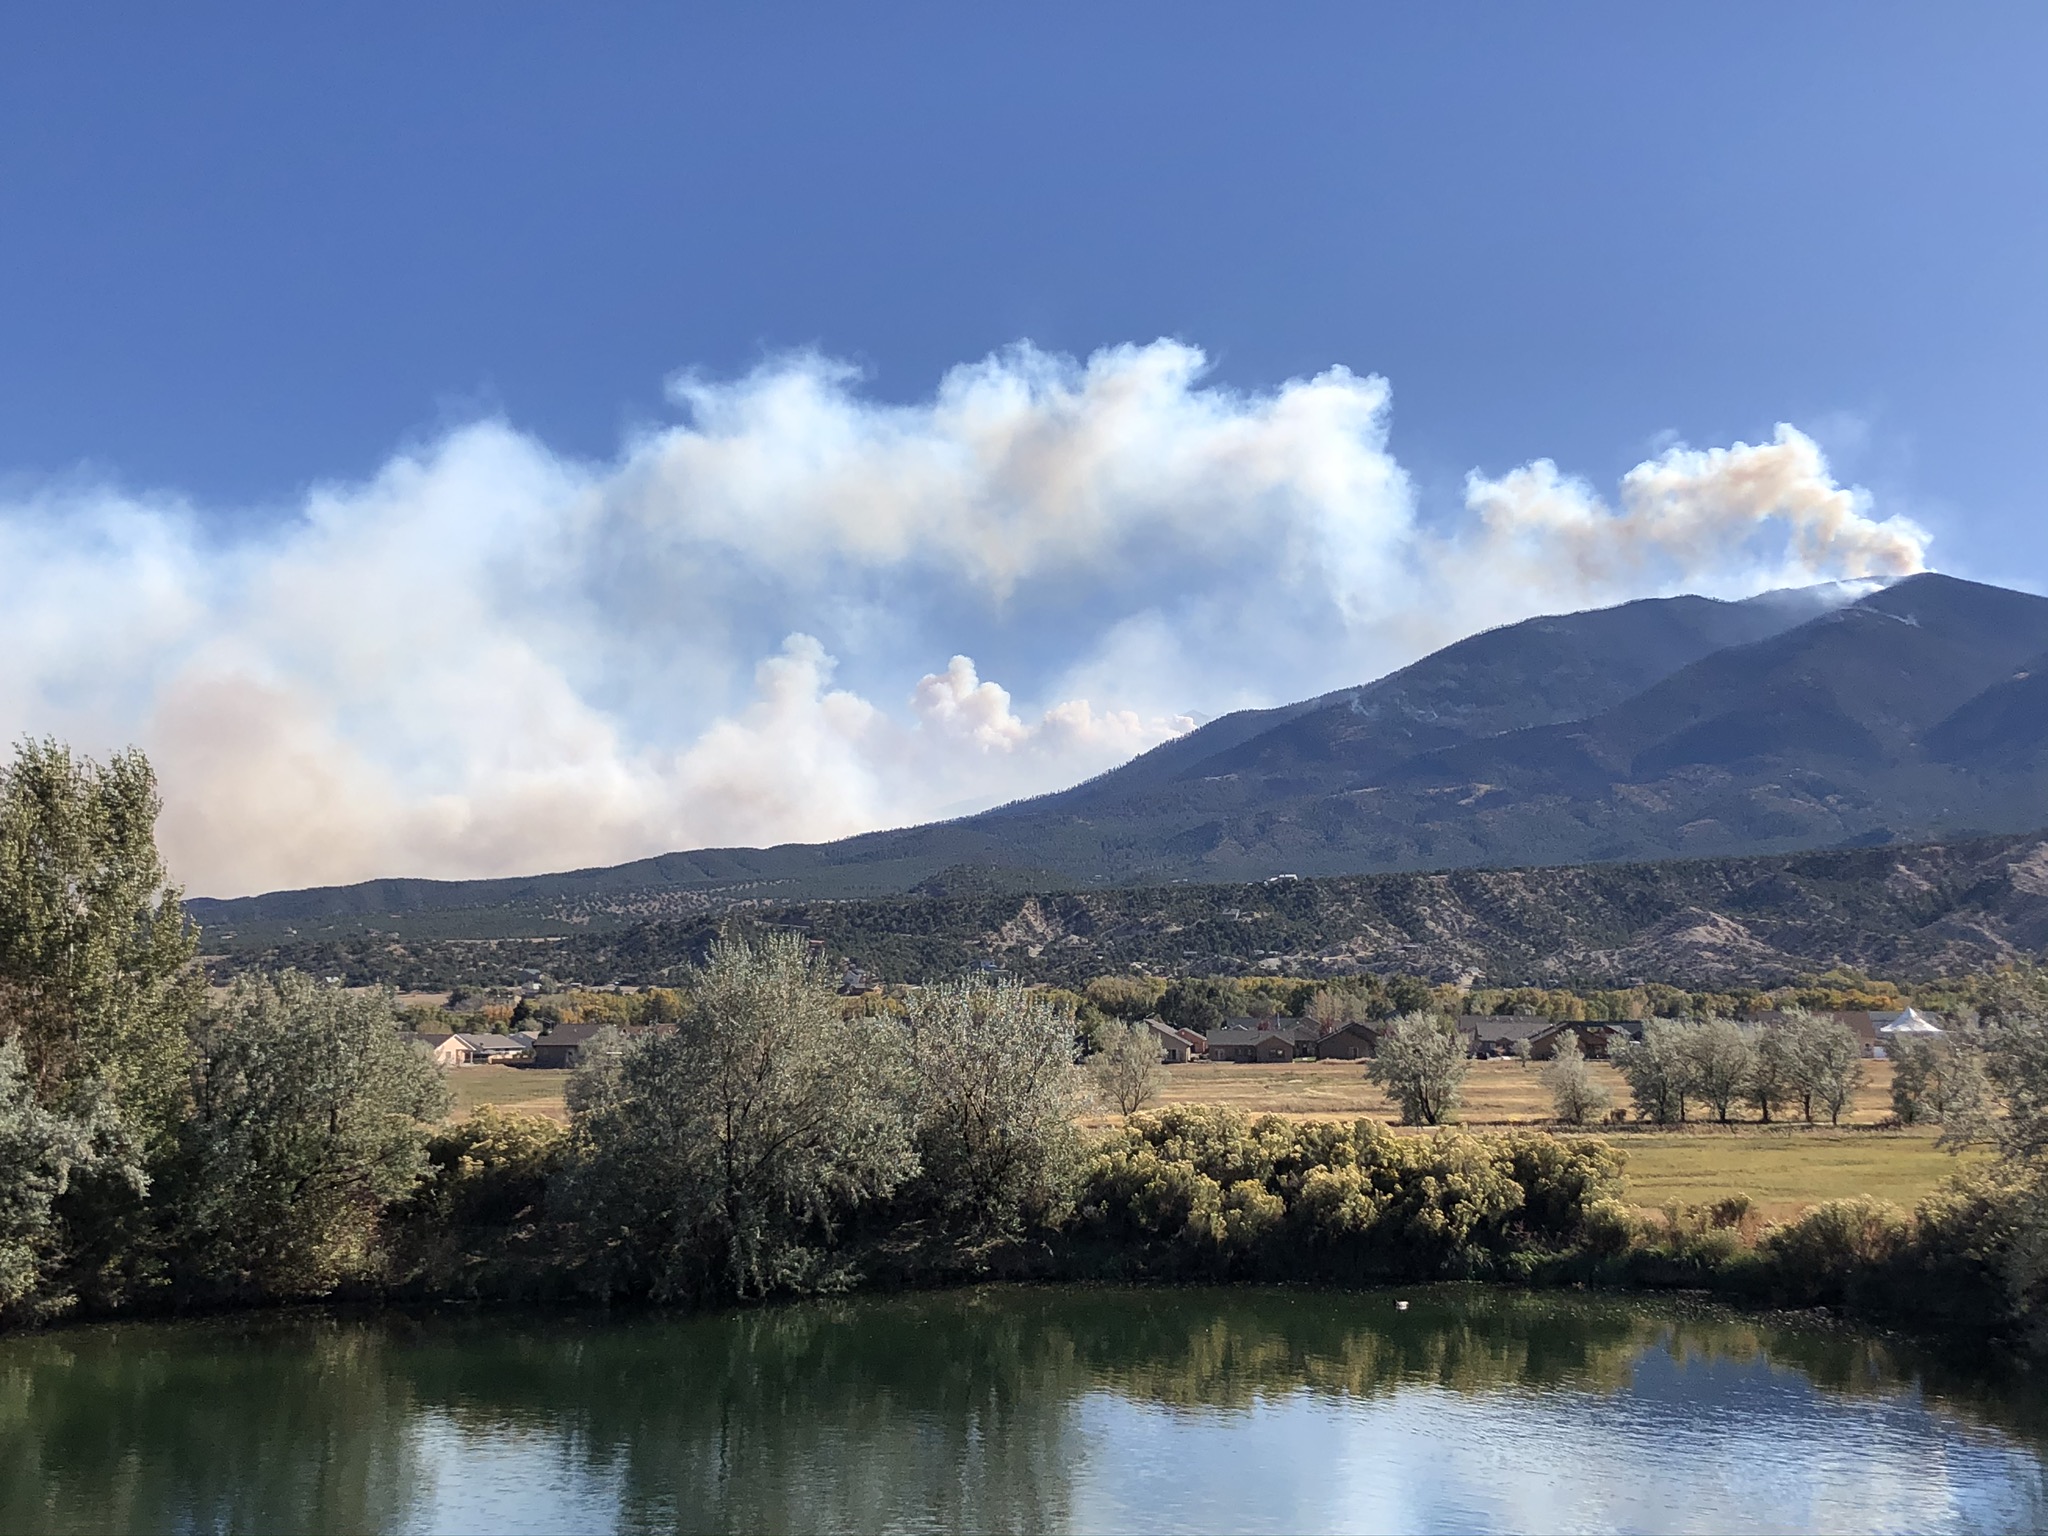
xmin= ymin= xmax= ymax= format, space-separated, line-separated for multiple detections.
xmin=407 ymin=1106 xmax=2040 ymax=1348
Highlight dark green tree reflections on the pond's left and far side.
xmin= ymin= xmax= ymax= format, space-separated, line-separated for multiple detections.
xmin=0 ymin=1288 xmax=2048 ymax=1532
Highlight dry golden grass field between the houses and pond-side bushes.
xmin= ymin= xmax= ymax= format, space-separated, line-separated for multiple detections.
xmin=449 ymin=1061 xmax=1958 ymax=1221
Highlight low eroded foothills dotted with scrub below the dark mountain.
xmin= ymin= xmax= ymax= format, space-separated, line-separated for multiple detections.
xmin=215 ymin=834 xmax=2048 ymax=987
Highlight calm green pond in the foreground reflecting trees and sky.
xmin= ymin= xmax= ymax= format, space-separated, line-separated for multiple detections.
xmin=0 ymin=1288 xmax=2048 ymax=1536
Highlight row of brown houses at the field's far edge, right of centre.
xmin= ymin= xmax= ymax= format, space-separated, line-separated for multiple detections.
xmin=1149 ymin=1008 xmax=1942 ymax=1063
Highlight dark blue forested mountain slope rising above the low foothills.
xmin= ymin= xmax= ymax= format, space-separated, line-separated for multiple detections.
xmin=186 ymin=573 xmax=2048 ymax=942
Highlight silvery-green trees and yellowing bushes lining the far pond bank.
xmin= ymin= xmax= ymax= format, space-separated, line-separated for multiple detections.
xmin=12 ymin=741 xmax=2048 ymax=1343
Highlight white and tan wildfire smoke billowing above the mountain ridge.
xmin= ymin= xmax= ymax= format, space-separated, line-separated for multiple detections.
xmin=0 ymin=342 xmax=1925 ymax=893
